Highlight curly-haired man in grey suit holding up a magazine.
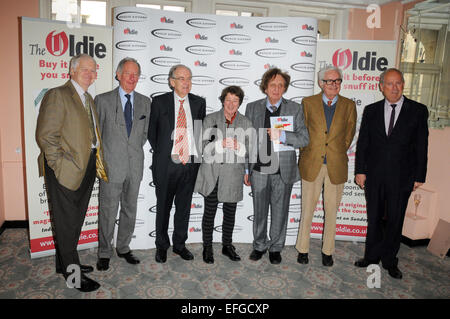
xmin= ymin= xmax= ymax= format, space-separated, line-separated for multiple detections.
xmin=244 ymin=68 xmax=309 ymax=264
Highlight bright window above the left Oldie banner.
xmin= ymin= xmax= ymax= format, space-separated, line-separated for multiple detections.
xmin=52 ymin=0 xmax=106 ymax=25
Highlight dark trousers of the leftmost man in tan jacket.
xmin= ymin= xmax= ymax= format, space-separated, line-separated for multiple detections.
xmin=44 ymin=149 xmax=96 ymax=277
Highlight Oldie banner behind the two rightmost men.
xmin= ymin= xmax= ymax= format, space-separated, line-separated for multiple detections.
xmin=311 ymin=40 xmax=397 ymax=241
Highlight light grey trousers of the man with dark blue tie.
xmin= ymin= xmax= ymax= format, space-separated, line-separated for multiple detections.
xmin=98 ymin=178 xmax=141 ymax=258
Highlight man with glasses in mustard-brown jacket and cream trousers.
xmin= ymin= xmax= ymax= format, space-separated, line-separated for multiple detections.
xmin=296 ymin=67 xmax=356 ymax=266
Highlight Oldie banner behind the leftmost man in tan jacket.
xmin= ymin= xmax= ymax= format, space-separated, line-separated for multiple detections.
xmin=22 ymin=17 xmax=112 ymax=258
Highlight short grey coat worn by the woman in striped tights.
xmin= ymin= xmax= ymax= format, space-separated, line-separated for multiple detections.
xmin=194 ymin=109 xmax=253 ymax=203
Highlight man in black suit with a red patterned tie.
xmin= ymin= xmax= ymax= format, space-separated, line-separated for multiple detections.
xmin=148 ymin=64 xmax=206 ymax=263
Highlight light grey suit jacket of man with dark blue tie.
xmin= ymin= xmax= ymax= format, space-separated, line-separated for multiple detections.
xmin=95 ymin=87 xmax=150 ymax=183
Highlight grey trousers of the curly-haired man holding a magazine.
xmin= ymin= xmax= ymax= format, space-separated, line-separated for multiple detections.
xmin=250 ymin=171 xmax=293 ymax=252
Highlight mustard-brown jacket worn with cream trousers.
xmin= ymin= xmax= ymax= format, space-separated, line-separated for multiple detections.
xmin=299 ymin=93 xmax=356 ymax=184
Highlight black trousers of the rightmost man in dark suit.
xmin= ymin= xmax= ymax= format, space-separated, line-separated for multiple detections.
xmin=364 ymin=182 xmax=412 ymax=268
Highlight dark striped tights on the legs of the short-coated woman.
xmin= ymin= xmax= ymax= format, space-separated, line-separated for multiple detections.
xmin=202 ymin=181 xmax=237 ymax=246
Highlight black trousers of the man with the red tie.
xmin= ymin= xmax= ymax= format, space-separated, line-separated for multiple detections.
xmin=155 ymin=160 xmax=199 ymax=250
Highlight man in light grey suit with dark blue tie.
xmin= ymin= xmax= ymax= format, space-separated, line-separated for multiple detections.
xmin=95 ymin=58 xmax=151 ymax=270
